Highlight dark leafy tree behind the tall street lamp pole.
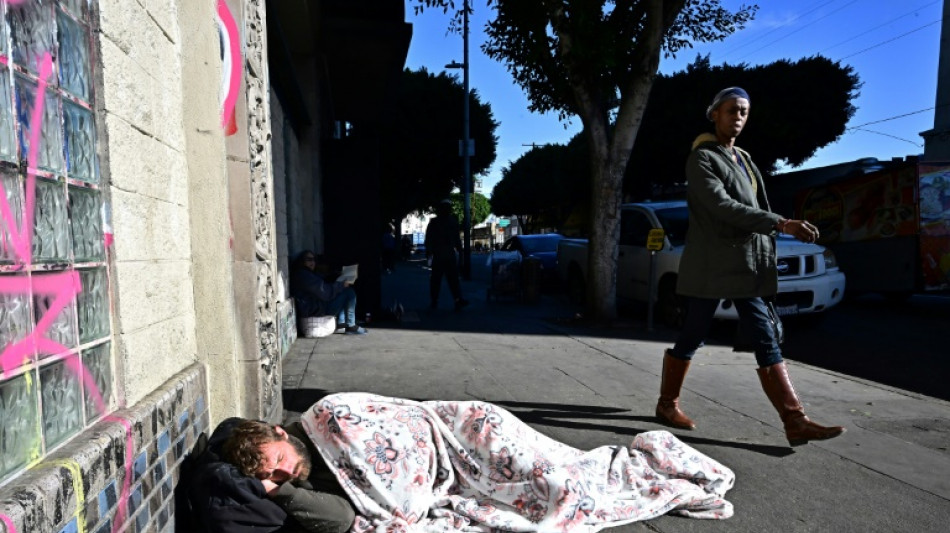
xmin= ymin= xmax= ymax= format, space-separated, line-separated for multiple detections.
xmin=380 ymin=69 xmax=498 ymax=224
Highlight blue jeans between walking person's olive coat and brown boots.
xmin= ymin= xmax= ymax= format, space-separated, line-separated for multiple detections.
xmin=671 ymin=297 xmax=782 ymax=367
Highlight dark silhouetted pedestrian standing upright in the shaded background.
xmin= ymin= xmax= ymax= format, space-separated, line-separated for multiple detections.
xmin=425 ymin=199 xmax=468 ymax=311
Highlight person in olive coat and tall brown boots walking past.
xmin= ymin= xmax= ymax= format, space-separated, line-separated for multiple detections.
xmin=656 ymin=87 xmax=844 ymax=446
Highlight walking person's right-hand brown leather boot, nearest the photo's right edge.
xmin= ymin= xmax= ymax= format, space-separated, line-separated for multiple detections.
xmin=756 ymin=362 xmax=845 ymax=446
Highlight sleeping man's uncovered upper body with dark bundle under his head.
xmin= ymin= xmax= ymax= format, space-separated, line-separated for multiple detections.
xmin=187 ymin=418 xmax=356 ymax=533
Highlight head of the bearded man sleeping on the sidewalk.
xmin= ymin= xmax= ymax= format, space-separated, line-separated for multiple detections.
xmin=222 ymin=420 xmax=310 ymax=483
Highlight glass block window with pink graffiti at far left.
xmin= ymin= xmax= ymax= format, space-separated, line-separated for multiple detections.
xmin=0 ymin=0 xmax=115 ymax=484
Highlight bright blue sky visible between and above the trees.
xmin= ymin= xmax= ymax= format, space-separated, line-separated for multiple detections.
xmin=406 ymin=0 xmax=950 ymax=195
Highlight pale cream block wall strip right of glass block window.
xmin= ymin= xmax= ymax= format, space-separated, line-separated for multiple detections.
xmin=96 ymin=0 xmax=200 ymax=405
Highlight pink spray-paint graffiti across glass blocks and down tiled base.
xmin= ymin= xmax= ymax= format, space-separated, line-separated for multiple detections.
xmin=0 ymin=46 xmax=134 ymax=533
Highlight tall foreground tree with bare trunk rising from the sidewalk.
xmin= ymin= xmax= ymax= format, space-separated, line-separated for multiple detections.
xmin=416 ymin=0 xmax=757 ymax=320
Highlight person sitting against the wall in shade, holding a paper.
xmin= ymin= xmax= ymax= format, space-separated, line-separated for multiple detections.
xmin=290 ymin=250 xmax=366 ymax=335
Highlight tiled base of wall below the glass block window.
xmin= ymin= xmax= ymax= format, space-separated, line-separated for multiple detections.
xmin=0 ymin=364 xmax=209 ymax=533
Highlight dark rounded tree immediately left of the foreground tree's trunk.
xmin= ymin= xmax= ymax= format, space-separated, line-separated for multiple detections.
xmin=492 ymin=136 xmax=590 ymax=233
